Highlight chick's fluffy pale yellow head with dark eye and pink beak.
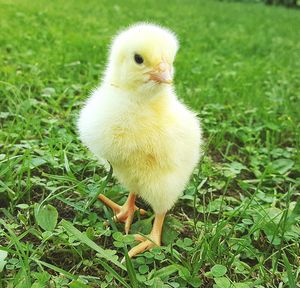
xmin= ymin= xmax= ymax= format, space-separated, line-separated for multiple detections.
xmin=105 ymin=23 xmax=179 ymax=93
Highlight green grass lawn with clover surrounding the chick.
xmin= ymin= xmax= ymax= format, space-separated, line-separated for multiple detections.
xmin=0 ymin=0 xmax=300 ymax=288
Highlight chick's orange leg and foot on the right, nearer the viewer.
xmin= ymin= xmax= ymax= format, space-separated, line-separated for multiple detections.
xmin=128 ymin=213 xmax=166 ymax=257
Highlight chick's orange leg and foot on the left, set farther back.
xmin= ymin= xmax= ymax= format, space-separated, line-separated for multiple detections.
xmin=98 ymin=193 xmax=146 ymax=234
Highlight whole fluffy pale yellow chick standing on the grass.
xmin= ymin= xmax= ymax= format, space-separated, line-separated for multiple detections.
xmin=78 ymin=23 xmax=201 ymax=257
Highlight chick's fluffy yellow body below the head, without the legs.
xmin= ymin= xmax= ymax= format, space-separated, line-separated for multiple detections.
xmin=79 ymin=84 xmax=201 ymax=213
